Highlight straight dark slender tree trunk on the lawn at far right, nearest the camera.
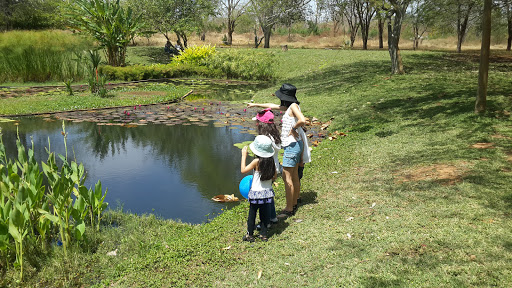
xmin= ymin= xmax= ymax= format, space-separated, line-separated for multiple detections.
xmin=475 ymin=0 xmax=492 ymax=113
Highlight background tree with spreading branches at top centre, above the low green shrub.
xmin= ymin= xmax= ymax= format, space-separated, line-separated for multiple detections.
xmin=250 ymin=0 xmax=310 ymax=48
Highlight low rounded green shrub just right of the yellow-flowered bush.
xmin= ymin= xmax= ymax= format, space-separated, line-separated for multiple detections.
xmin=208 ymin=49 xmax=274 ymax=80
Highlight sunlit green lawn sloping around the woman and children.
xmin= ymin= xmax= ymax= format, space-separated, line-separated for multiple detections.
xmin=2 ymin=49 xmax=512 ymax=287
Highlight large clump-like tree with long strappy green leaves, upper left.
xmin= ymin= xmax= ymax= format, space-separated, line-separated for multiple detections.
xmin=68 ymin=0 xmax=142 ymax=66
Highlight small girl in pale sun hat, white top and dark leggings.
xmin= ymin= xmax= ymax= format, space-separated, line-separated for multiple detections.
xmin=240 ymin=135 xmax=277 ymax=242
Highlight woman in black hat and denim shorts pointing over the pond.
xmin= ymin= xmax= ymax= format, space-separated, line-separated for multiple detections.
xmin=247 ymin=83 xmax=306 ymax=218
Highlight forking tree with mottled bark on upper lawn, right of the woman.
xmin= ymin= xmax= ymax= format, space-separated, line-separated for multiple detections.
xmin=386 ymin=0 xmax=411 ymax=74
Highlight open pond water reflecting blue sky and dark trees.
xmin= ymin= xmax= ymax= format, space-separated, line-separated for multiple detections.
xmin=0 ymin=118 xmax=254 ymax=223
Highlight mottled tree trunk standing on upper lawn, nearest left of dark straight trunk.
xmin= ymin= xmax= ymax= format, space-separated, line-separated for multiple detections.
xmin=388 ymin=7 xmax=407 ymax=74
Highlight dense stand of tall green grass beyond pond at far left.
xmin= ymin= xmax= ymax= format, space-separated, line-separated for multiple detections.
xmin=0 ymin=31 xmax=93 ymax=82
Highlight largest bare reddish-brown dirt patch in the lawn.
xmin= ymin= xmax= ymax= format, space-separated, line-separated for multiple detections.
xmin=395 ymin=162 xmax=469 ymax=185
